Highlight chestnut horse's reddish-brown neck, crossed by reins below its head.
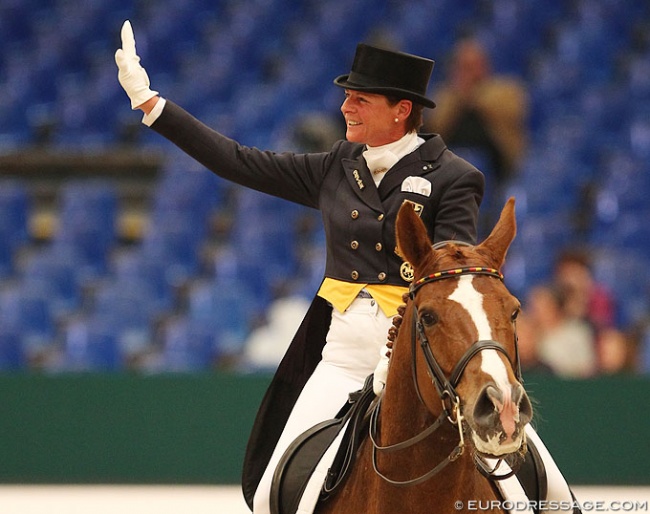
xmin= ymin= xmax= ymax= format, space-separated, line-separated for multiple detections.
xmin=359 ymin=309 xmax=483 ymax=513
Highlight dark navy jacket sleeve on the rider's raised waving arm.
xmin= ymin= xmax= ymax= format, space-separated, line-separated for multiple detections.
xmin=151 ymin=100 xmax=333 ymax=208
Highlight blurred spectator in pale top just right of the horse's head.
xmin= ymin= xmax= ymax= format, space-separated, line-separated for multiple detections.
xmin=527 ymin=286 xmax=597 ymax=378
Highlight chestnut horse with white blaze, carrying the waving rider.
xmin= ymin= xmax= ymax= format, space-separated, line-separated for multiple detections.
xmin=315 ymin=199 xmax=532 ymax=514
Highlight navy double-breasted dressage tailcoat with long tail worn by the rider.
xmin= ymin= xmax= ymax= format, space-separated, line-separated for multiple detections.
xmin=151 ymin=101 xmax=484 ymax=506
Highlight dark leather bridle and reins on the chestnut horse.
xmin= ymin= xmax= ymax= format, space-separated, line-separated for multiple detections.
xmin=369 ymin=260 xmax=523 ymax=486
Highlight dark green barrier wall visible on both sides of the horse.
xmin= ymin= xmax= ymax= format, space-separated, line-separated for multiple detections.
xmin=0 ymin=374 xmax=650 ymax=485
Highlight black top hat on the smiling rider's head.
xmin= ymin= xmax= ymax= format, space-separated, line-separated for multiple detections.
xmin=334 ymin=43 xmax=436 ymax=108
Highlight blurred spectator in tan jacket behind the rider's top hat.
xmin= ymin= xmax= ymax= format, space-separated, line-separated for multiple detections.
xmin=425 ymin=39 xmax=529 ymax=182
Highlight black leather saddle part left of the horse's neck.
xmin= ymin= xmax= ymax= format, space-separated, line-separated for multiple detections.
xmin=270 ymin=375 xmax=376 ymax=514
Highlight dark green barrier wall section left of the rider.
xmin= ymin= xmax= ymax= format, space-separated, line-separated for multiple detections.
xmin=0 ymin=374 xmax=269 ymax=484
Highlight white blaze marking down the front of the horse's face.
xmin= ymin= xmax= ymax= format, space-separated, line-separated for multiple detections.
xmin=449 ymin=275 xmax=510 ymax=388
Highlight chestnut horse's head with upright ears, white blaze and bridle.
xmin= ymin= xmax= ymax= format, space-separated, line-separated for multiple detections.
xmin=387 ymin=198 xmax=532 ymax=457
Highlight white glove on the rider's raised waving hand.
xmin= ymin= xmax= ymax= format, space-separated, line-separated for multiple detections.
xmin=115 ymin=20 xmax=158 ymax=110
